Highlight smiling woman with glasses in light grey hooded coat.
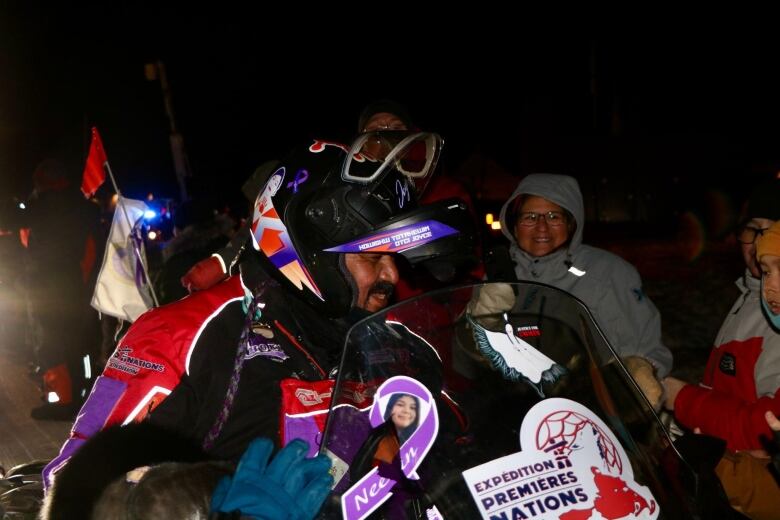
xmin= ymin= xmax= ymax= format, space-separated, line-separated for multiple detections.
xmin=488 ymin=174 xmax=672 ymax=380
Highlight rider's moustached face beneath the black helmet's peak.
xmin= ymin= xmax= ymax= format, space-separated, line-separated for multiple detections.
xmin=344 ymin=253 xmax=398 ymax=312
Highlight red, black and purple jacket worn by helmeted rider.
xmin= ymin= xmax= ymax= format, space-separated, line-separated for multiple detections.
xmin=44 ymin=275 xmax=336 ymax=486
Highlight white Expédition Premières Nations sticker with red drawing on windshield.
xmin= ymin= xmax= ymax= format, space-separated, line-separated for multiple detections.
xmin=463 ymin=398 xmax=659 ymax=520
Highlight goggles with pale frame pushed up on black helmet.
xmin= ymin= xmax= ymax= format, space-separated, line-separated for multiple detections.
xmin=341 ymin=130 xmax=443 ymax=194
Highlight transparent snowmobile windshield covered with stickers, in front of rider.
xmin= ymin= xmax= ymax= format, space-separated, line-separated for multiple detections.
xmin=320 ymin=283 xmax=695 ymax=520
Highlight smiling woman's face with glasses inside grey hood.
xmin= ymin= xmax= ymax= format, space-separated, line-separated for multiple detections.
xmin=514 ymin=195 xmax=569 ymax=256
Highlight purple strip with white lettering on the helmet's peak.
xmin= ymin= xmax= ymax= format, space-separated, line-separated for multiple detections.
xmin=325 ymin=220 xmax=459 ymax=253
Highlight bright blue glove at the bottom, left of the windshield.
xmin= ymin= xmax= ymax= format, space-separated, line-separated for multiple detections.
xmin=211 ymin=438 xmax=333 ymax=520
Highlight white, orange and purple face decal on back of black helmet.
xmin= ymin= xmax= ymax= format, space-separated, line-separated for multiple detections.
xmin=251 ymin=166 xmax=324 ymax=301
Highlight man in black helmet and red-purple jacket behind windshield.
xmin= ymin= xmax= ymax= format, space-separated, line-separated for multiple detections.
xmin=44 ymin=132 xmax=473 ymax=514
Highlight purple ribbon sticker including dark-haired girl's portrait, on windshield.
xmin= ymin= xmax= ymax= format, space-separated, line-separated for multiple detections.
xmin=341 ymin=376 xmax=439 ymax=520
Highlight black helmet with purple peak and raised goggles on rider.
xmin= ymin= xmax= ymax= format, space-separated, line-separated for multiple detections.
xmin=251 ymin=132 xmax=473 ymax=317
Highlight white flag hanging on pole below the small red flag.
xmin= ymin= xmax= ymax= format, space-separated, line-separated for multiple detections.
xmin=92 ymin=196 xmax=152 ymax=322
